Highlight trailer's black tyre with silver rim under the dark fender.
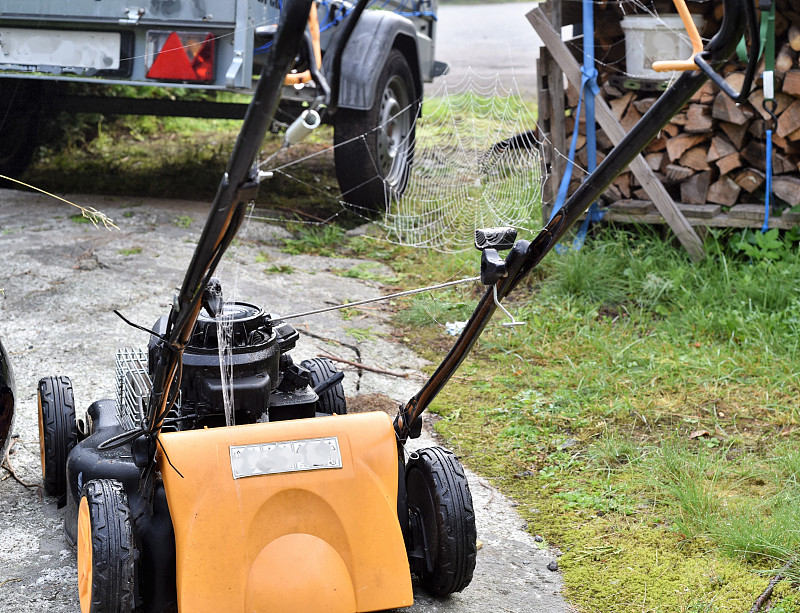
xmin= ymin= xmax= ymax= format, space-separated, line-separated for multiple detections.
xmin=333 ymin=49 xmax=419 ymax=211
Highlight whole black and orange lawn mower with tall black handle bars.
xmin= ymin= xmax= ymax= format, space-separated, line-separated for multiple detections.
xmin=32 ymin=0 xmax=758 ymax=613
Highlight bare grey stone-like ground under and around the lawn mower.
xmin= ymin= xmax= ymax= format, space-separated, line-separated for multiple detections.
xmin=0 ymin=190 xmax=569 ymax=613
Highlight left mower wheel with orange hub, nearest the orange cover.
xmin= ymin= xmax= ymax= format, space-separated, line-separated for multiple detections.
xmin=77 ymin=479 xmax=134 ymax=613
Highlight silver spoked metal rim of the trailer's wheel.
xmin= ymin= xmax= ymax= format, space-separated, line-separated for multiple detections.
xmin=378 ymin=76 xmax=411 ymax=186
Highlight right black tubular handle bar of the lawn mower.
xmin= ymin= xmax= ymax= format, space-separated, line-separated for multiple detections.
xmin=394 ymin=0 xmax=758 ymax=443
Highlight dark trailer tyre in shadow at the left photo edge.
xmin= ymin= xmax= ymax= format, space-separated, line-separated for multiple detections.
xmin=0 ymin=79 xmax=42 ymax=179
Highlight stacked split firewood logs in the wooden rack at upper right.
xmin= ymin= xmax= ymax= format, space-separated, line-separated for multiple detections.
xmin=567 ymin=0 xmax=800 ymax=212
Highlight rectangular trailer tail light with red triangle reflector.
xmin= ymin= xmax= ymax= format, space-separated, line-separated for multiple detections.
xmin=146 ymin=31 xmax=216 ymax=82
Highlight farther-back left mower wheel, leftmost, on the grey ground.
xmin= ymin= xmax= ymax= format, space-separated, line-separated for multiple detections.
xmin=36 ymin=377 xmax=78 ymax=496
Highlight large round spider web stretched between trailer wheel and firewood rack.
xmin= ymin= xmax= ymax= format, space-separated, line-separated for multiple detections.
xmin=378 ymin=71 xmax=544 ymax=251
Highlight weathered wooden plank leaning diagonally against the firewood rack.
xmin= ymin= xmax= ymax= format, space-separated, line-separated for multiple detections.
xmin=526 ymin=7 xmax=706 ymax=261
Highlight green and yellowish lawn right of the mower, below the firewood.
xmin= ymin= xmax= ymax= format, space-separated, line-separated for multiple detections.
xmin=376 ymin=229 xmax=800 ymax=612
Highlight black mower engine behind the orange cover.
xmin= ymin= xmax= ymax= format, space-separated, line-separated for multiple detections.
xmin=133 ymin=302 xmax=320 ymax=432
